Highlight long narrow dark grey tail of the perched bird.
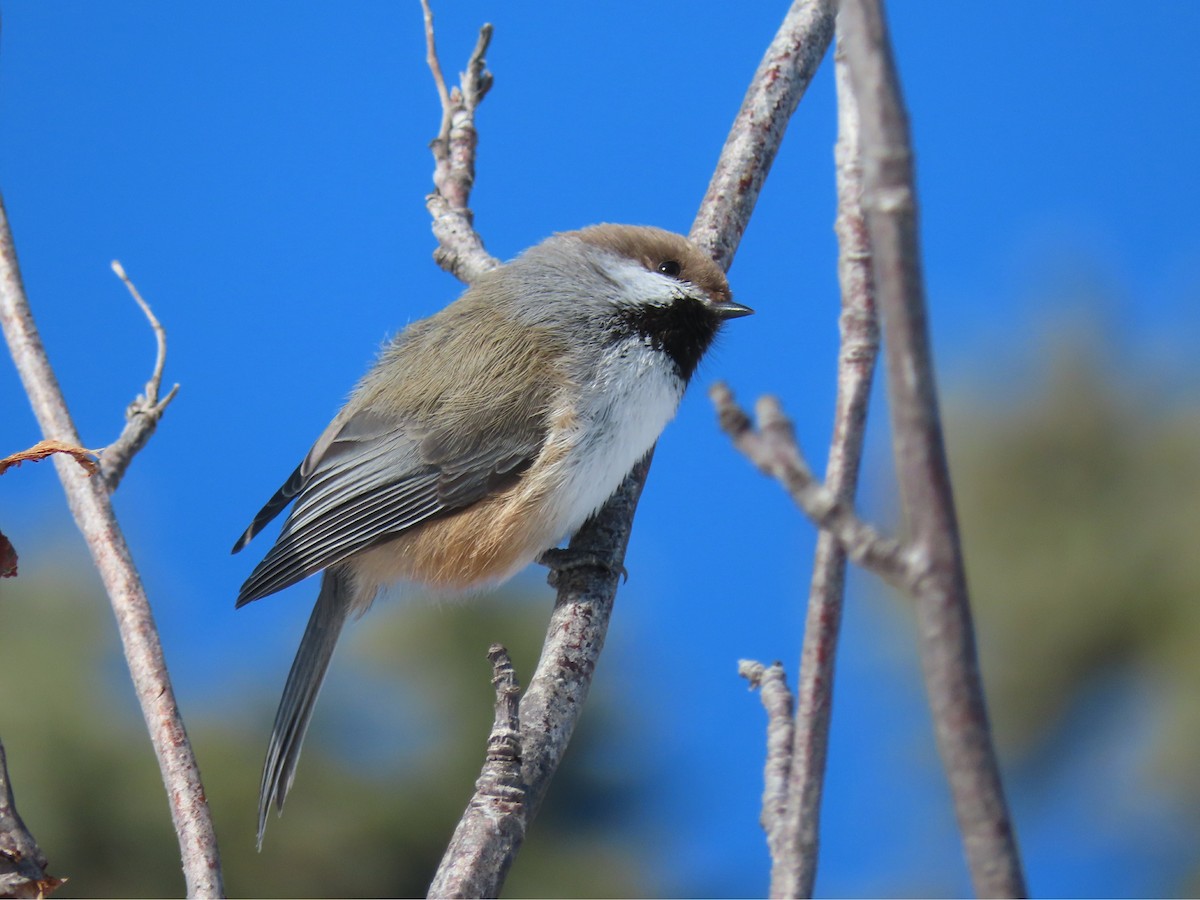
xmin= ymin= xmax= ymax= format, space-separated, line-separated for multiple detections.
xmin=258 ymin=569 xmax=355 ymax=850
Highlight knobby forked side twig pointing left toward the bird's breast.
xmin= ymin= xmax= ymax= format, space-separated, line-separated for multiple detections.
xmin=708 ymin=382 xmax=913 ymax=589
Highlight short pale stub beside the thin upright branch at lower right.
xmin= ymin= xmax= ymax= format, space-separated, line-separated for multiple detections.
xmin=738 ymin=659 xmax=794 ymax=880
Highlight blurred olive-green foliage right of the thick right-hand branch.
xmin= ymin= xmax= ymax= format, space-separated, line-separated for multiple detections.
xmin=946 ymin=338 xmax=1200 ymax=811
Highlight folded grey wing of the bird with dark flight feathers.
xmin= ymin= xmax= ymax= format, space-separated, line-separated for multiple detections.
xmin=234 ymin=412 xmax=546 ymax=606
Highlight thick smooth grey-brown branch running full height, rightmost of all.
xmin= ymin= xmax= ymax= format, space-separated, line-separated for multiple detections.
xmin=839 ymin=0 xmax=1026 ymax=896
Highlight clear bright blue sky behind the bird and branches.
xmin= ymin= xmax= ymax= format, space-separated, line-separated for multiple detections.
xmin=0 ymin=0 xmax=1200 ymax=894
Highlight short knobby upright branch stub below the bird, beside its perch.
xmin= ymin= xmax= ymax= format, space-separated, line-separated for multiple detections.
xmin=428 ymin=643 xmax=524 ymax=898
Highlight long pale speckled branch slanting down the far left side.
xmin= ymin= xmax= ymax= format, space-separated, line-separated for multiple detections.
xmin=0 ymin=198 xmax=223 ymax=896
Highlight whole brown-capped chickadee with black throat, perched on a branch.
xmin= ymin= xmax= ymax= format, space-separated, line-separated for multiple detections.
xmin=234 ymin=224 xmax=751 ymax=846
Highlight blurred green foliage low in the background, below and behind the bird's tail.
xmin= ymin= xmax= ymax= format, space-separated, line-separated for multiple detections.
xmin=0 ymin=573 xmax=661 ymax=898
